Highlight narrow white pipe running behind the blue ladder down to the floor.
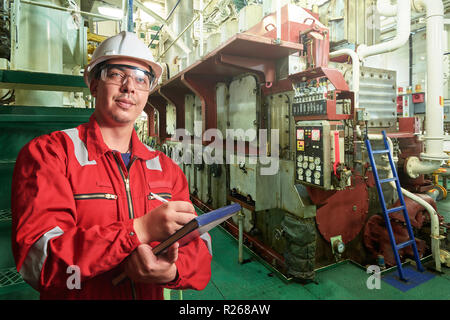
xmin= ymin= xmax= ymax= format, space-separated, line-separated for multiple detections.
xmin=356 ymin=126 xmax=441 ymax=271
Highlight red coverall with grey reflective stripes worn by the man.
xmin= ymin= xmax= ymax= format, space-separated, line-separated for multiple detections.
xmin=11 ymin=116 xmax=211 ymax=299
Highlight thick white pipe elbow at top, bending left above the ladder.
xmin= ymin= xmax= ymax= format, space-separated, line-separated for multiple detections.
xmin=357 ymin=0 xmax=411 ymax=61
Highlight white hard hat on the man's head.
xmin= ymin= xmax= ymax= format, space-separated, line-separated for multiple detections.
xmin=84 ymin=31 xmax=162 ymax=87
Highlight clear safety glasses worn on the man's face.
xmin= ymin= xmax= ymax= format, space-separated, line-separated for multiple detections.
xmin=100 ymin=64 xmax=155 ymax=91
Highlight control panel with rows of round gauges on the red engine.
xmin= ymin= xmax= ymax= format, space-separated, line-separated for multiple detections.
xmin=295 ymin=120 xmax=344 ymax=190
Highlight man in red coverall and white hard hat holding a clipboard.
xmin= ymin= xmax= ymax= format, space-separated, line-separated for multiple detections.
xmin=12 ymin=32 xmax=211 ymax=299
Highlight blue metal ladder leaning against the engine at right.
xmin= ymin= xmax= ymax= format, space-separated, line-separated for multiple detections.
xmin=365 ymin=130 xmax=424 ymax=281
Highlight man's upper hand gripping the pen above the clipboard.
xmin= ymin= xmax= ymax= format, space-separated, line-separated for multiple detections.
xmin=133 ymin=201 xmax=196 ymax=243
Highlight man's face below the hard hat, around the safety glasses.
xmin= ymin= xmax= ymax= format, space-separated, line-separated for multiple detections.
xmin=90 ymin=58 xmax=150 ymax=126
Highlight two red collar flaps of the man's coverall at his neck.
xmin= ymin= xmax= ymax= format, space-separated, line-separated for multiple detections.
xmin=85 ymin=114 xmax=157 ymax=161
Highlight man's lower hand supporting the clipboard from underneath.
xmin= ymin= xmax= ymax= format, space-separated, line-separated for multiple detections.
xmin=124 ymin=242 xmax=178 ymax=284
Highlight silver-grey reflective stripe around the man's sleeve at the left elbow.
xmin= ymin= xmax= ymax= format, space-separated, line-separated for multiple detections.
xmin=19 ymin=226 xmax=64 ymax=290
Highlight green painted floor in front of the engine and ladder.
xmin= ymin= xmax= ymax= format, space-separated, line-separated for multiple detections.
xmin=179 ymin=227 xmax=450 ymax=300
